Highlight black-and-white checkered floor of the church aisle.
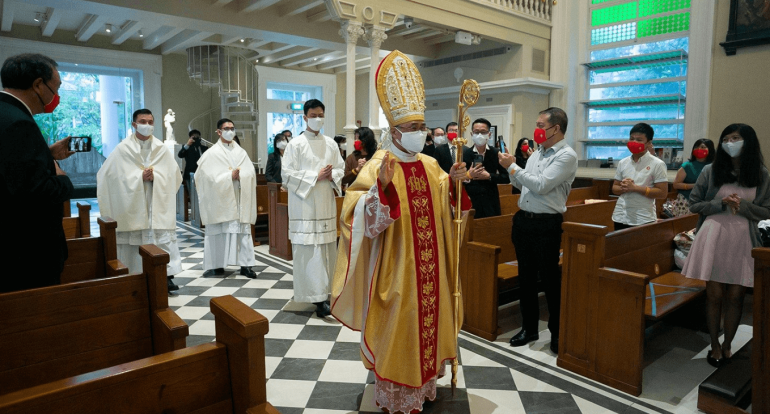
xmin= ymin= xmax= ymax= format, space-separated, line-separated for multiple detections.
xmin=73 ymin=199 xmax=752 ymax=414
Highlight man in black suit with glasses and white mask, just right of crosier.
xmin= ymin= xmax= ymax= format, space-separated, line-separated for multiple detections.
xmin=463 ymin=118 xmax=511 ymax=218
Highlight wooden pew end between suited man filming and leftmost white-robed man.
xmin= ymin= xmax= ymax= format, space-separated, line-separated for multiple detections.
xmin=61 ymin=217 xmax=128 ymax=283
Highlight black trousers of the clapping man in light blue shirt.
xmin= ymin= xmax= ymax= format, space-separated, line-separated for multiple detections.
xmin=511 ymin=210 xmax=564 ymax=337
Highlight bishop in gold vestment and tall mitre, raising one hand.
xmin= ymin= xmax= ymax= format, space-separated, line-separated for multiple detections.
xmin=332 ymin=51 xmax=470 ymax=413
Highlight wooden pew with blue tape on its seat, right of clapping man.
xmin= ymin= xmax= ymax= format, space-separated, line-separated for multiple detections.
xmin=557 ymin=215 xmax=705 ymax=395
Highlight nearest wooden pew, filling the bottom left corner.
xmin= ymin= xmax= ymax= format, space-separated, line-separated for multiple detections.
xmin=0 ymin=296 xmax=278 ymax=414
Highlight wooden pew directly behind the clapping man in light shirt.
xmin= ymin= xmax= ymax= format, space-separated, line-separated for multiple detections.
xmin=460 ymin=200 xmax=616 ymax=341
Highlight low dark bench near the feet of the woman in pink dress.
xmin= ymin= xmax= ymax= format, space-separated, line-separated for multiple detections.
xmin=698 ymin=340 xmax=753 ymax=414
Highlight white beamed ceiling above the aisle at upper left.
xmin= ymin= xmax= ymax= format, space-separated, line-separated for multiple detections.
xmin=0 ymin=0 xmax=468 ymax=72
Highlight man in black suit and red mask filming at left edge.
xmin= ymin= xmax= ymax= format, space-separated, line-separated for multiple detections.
xmin=0 ymin=54 xmax=73 ymax=292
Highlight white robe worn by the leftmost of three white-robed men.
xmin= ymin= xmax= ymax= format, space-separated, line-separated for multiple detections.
xmin=96 ymin=134 xmax=182 ymax=276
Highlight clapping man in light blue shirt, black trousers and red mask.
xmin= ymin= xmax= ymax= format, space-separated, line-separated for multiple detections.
xmin=498 ymin=108 xmax=577 ymax=354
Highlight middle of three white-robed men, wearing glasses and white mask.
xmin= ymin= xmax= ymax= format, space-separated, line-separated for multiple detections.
xmin=195 ymin=118 xmax=257 ymax=279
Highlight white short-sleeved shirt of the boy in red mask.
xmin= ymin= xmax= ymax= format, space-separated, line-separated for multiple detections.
xmin=612 ymin=152 xmax=668 ymax=226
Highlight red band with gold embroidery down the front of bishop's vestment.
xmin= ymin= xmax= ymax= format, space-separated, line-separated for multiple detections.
xmin=401 ymin=161 xmax=439 ymax=382
